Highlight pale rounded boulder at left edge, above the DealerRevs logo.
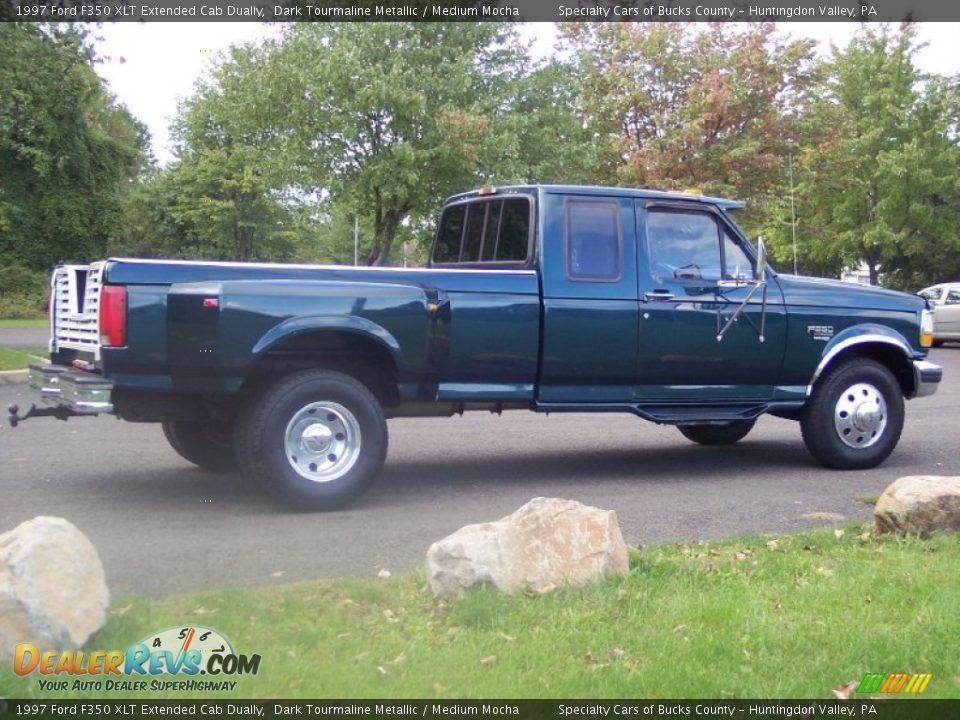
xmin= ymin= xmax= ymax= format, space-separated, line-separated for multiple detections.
xmin=0 ymin=517 xmax=110 ymax=660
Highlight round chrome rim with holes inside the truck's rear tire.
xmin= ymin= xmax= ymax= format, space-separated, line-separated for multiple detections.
xmin=283 ymin=401 xmax=361 ymax=483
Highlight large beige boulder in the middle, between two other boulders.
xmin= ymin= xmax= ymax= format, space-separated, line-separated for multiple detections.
xmin=427 ymin=498 xmax=628 ymax=596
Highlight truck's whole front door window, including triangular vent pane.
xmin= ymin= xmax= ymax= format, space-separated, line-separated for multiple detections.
xmin=647 ymin=210 xmax=753 ymax=281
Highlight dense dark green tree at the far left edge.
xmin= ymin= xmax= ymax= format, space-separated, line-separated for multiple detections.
xmin=0 ymin=23 xmax=147 ymax=270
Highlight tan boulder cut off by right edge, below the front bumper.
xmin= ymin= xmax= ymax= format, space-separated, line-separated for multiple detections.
xmin=873 ymin=475 xmax=960 ymax=535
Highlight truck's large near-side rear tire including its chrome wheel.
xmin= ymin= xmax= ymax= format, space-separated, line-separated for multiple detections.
xmin=235 ymin=370 xmax=387 ymax=510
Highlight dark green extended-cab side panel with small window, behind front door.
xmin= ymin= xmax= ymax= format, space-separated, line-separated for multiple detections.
xmin=538 ymin=193 xmax=637 ymax=403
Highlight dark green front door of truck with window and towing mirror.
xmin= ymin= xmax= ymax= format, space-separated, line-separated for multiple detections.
xmin=636 ymin=200 xmax=786 ymax=402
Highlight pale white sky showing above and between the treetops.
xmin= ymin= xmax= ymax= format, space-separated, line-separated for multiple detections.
xmin=97 ymin=22 xmax=960 ymax=165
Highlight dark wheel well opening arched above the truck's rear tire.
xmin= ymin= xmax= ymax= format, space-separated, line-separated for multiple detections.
xmin=243 ymin=331 xmax=399 ymax=406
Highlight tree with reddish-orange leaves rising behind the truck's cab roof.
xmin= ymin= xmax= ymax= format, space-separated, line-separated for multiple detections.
xmin=564 ymin=23 xmax=812 ymax=228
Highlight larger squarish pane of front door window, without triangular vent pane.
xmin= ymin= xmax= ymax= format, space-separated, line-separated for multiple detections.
xmin=647 ymin=210 xmax=722 ymax=281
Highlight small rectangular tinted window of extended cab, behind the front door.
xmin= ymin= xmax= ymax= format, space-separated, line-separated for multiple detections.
xmin=566 ymin=200 xmax=623 ymax=282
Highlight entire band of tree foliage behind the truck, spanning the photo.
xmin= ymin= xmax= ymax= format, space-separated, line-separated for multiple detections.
xmin=0 ymin=23 xmax=960 ymax=288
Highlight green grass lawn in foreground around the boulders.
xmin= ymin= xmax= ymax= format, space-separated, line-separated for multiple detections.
xmin=0 ymin=526 xmax=960 ymax=699
